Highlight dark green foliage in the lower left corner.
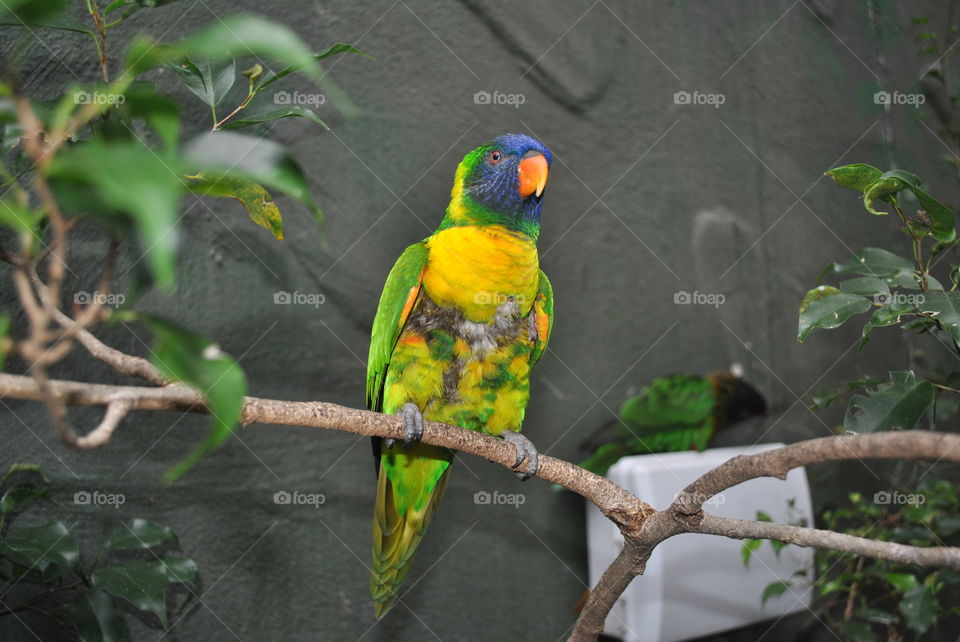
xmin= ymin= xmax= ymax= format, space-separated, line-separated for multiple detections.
xmin=0 ymin=464 xmax=198 ymax=642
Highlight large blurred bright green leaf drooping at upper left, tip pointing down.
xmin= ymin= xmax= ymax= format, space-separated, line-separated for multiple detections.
xmin=51 ymin=139 xmax=183 ymax=289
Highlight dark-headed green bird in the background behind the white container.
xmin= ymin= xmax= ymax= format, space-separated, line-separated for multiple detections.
xmin=580 ymin=372 xmax=767 ymax=475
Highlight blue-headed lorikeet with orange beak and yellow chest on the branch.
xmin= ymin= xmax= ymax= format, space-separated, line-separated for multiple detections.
xmin=367 ymin=134 xmax=553 ymax=617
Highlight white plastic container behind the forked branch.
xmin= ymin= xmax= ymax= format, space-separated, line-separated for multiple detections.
xmin=587 ymin=444 xmax=814 ymax=642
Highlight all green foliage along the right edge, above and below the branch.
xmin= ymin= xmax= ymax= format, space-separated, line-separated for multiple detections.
xmin=776 ymin=140 xmax=960 ymax=641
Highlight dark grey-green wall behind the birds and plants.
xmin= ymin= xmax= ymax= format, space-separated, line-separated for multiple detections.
xmin=0 ymin=0 xmax=955 ymax=640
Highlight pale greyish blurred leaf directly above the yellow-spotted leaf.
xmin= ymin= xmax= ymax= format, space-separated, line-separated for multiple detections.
xmin=184 ymin=132 xmax=322 ymax=218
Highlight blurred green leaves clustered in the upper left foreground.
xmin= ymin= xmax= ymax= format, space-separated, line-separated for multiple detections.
xmin=0 ymin=0 xmax=366 ymax=480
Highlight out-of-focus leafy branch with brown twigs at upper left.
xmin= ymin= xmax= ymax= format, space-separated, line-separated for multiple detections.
xmin=0 ymin=0 xmax=366 ymax=480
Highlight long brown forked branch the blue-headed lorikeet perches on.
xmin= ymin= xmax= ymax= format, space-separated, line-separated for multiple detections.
xmin=0 ymin=368 xmax=960 ymax=640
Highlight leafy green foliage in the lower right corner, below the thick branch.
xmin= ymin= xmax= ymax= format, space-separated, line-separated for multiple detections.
xmin=741 ymin=482 xmax=960 ymax=642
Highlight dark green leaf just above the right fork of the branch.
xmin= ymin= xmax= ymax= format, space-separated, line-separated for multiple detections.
xmin=843 ymin=371 xmax=934 ymax=433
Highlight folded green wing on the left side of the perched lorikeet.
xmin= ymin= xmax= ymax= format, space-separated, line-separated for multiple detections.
xmin=367 ymin=242 xmax=427 ymax=411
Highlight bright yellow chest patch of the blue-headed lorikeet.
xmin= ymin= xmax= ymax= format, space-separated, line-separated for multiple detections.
xmin=423 ymin=225 xmax=540 ymax=322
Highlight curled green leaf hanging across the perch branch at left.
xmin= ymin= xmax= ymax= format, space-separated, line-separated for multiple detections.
xmin=140 ymin=315 xmax=247 ymax=482
